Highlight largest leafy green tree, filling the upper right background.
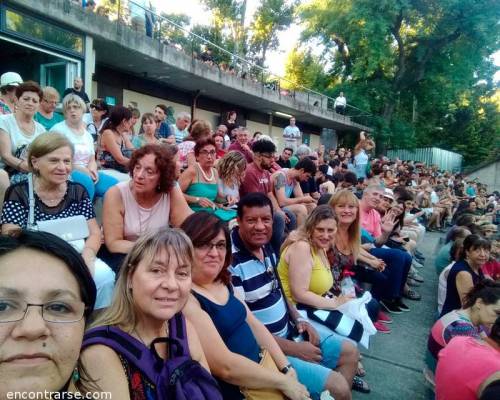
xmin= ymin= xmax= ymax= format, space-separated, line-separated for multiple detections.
xmin=299 ymin=0 xmax=500 ymax=162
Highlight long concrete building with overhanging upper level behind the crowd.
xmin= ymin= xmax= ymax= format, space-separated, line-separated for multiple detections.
xmin=0 ymin=0 xmax=370 ymax=147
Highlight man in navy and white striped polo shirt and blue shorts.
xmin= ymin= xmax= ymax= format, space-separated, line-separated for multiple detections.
xmin=231 ymin=193 xmax=359 ymax=400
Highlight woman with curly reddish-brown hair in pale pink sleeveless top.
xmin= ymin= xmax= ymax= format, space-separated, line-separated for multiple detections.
xmin=101 ymin=144 xmax=192 ymax=269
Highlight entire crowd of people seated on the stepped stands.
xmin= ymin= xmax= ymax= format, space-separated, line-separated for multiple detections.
xmin=0 ymin=69 xmax=500 ymax=400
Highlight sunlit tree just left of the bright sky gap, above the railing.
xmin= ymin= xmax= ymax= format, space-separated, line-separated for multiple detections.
xmin=249 ymin=0 xmax=295 ymax=66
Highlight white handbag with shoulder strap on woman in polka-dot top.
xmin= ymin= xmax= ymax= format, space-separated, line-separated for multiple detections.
xmin=27 ymin=174 xmax=90 ymax=253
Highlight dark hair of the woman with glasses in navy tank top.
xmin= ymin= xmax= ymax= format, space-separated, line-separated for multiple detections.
xmin=181 ymin=211 xmax=231 ymax=285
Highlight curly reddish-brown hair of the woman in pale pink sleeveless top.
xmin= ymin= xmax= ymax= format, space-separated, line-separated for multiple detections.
xmin=129 ymin=144 xmax=177 ymax=193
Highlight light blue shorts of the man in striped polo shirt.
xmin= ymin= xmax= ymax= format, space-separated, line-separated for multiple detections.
xmin=288 ymin=311 xmax=349 ymax=399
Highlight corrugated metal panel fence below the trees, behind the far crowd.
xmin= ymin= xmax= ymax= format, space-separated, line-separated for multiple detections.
xmin=387 ymin=147 xmax=462 ymax=172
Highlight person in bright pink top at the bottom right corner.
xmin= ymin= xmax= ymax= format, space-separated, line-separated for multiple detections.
xmin=436 ymin=316 xmax=500 ymax=400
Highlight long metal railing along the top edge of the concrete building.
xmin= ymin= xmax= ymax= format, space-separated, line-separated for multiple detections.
xmin=87 ymin=0 xmax=373 ymax=126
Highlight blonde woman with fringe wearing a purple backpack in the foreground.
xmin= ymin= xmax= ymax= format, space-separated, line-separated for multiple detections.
xmin=77 ymin=228 xmax=218 ymax=400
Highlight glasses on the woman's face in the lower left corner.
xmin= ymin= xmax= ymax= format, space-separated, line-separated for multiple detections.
xmin=0 ymin=298 xmax=86 ymax=323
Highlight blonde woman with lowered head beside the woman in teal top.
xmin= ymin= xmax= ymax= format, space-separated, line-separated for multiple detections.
xmin=215 ymin=151 xmax=247 ymax=204
